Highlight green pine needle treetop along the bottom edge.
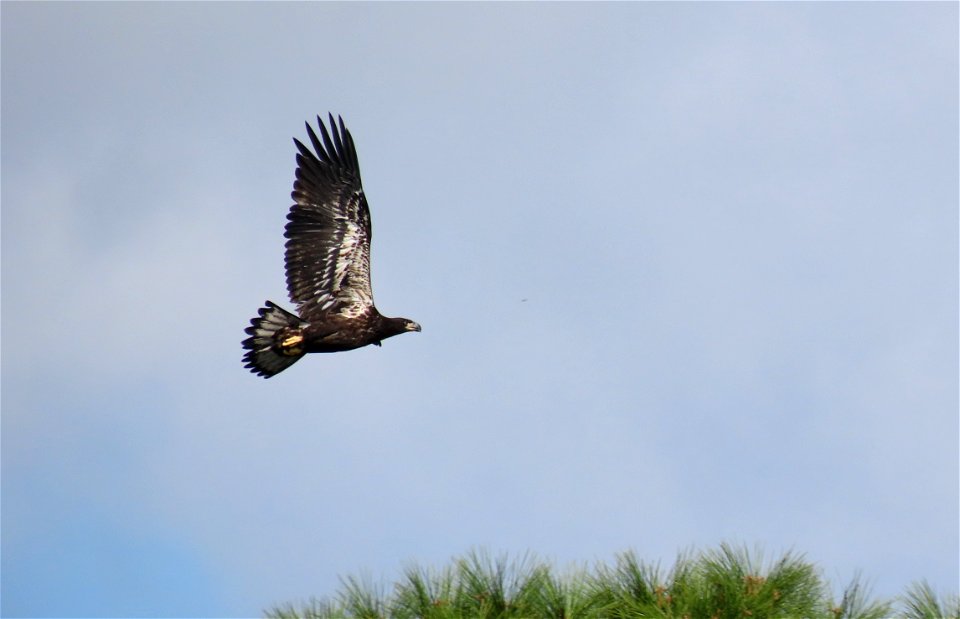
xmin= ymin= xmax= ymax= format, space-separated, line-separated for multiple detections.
xmin=266 ymin=544 xmax=960 ymax=619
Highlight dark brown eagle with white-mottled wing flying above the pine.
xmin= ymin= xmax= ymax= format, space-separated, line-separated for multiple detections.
xmin=243 ymin=114 xmax=420 ymax=378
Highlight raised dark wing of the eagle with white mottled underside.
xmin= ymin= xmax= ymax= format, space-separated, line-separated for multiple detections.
xmin=284 ymin=114 xmax=373 ymax=321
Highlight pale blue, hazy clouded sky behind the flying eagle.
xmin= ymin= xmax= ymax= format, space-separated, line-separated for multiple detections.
xmin=2 ymin=2 xmax=958 ymax=617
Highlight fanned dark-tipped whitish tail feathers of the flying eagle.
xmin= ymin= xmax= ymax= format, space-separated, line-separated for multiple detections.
xmin=243 ymin=301 xmax=307 ymax=378
